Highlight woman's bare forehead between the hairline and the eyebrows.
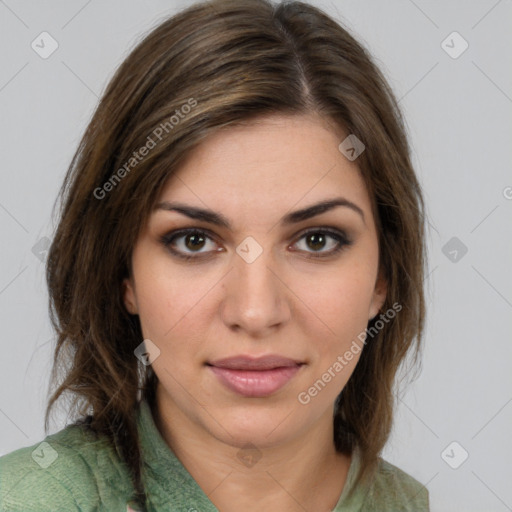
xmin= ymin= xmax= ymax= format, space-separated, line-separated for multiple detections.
xmin=159 ymin=115 xmax=371 ymax=227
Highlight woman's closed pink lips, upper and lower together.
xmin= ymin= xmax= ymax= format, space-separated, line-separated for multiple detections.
xmin=208 ymin=355 xmax=303 ymax=397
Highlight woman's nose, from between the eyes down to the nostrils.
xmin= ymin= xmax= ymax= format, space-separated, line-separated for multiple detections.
xmin=220 ymin=244 xmax=291 ymax=337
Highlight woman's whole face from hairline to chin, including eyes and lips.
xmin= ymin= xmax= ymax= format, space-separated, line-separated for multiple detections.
xmin=124 ymin=116 xmax=385 ymax=447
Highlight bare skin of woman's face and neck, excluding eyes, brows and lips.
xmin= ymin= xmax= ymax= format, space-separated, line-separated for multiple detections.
xmin=124 ymin=115 xmax=386 ymax=512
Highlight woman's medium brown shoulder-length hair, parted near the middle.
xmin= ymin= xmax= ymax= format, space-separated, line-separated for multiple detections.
xmin=45 ymin=0 xmax=425 ymax=501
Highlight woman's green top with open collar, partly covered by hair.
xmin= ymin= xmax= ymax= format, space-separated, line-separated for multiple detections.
xmin=0 ymin=402 xmax=429 ymax=512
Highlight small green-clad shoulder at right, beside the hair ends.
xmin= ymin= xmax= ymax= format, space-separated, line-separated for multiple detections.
xmin=365 ymin=458 xmax=429 ymax=512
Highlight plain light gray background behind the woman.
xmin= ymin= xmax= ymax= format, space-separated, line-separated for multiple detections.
xmin=0 ymin=0 xmax=512 ymax=512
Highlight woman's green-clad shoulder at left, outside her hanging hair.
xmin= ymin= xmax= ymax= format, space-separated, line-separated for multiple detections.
xmin=0 ymin=425 xmax=131 ymax=512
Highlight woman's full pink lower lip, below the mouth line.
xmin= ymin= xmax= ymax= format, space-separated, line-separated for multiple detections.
xmin=210 ymin=365 xmax=300 ymax=398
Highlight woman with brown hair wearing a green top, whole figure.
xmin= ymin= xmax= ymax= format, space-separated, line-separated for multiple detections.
xmin=0 ymin=0 xmax=428 ymax=512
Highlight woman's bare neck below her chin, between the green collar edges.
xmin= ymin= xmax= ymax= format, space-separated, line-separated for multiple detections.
xmin=155 ymin=386 xmax=351 ymax=512
